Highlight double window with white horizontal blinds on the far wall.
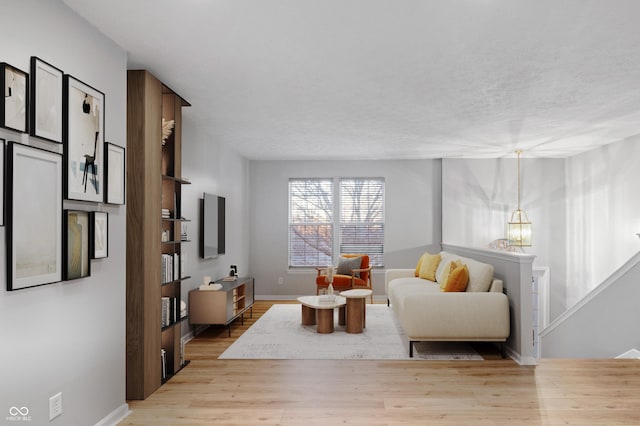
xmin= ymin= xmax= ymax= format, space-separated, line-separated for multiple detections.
xmin=289 ymin=178 xmax=384 ymax=267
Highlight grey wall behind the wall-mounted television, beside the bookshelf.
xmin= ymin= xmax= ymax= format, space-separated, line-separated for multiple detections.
xmin=182 ymin=111 xmax=250 ymax=335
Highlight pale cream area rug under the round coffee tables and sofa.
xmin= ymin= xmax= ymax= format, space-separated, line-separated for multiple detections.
xmin=219 ymin=304 xmax=483 ymax=360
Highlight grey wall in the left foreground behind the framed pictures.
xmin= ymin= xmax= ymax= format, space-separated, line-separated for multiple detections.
xmin=0 ymin=0 xmax=127 ymax=425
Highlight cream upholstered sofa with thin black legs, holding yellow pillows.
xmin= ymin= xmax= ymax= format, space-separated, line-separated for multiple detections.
xmin=385 ymin=251 xmax=510 ymax=356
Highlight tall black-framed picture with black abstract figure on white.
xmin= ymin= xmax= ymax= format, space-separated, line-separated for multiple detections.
xmin=63 ymin=75 xmax=104 ymax=203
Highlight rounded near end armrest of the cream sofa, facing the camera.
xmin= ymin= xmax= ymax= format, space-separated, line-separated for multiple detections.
xmin=399 ymin=292 xmax=510 ymax=341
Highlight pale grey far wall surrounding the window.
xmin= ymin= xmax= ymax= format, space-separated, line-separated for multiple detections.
xmin=249 ymin=160 xmax=441 ymax=297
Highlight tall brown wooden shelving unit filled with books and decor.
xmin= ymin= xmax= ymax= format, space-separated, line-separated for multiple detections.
xmin=126 ymin=71 xmax=189 ymax=399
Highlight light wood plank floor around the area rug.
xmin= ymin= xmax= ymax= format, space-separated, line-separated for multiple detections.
xmin=120 ymin=301 xmax=640 ymax=426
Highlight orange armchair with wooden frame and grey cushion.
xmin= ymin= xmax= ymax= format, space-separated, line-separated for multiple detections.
xmin=316 ymin=254 xmax=373 ymax=303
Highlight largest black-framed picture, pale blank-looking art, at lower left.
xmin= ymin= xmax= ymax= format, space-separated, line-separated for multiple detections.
xmin=6 ymin=142 xmax=62 ymax=290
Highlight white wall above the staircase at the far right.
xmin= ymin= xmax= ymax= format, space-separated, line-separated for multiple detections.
xmin=564 ymin=137 xmax=640 ymax=307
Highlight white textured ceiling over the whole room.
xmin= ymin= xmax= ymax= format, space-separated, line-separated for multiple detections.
xmin=64 ymin=0 xmax=640 ymax=159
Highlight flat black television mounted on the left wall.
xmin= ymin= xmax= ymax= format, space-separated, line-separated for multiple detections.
xmin=200 ymin=192 xmax=226 ymax=259
